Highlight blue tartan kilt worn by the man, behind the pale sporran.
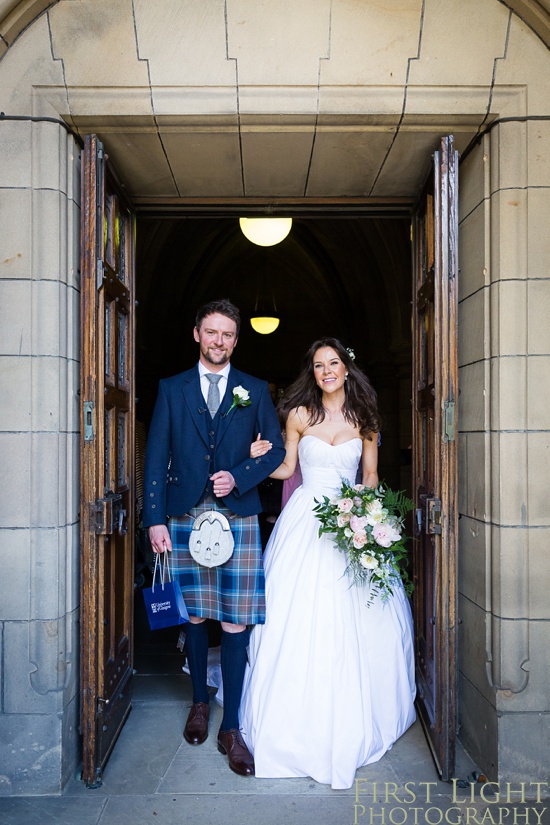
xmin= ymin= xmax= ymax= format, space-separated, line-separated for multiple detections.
xmin=168 ymin=500 xmax=265 ymax=624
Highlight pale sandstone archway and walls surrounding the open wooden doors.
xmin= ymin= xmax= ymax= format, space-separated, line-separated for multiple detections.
xmin=0 ymin=0 xmax=550 ymax=793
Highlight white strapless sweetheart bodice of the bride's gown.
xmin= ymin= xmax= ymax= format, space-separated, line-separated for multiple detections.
xmin=298 ymin=435 xmax=362 ymax=495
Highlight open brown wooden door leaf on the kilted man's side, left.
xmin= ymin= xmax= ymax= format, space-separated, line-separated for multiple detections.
xmin=80 ymin=135 xmax=135 ymax=787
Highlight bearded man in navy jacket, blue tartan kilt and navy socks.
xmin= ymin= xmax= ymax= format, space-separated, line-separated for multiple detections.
xmin=143 ymin=300 xmax=285 ymax=776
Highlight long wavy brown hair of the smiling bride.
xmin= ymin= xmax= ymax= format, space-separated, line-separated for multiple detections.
xmin=277 ymin=338 xmax=382 ymax=441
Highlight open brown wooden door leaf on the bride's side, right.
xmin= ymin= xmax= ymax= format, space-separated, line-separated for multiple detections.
xmin=413 ymin=137 xmax=458 ymax=780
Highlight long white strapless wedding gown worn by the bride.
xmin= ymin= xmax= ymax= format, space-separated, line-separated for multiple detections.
xmin=240 ymin=435 xmax=415 ymax=788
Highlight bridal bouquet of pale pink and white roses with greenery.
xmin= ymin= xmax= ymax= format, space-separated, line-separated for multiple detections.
xmin=313 ymin=481 xmax=413 ymax=602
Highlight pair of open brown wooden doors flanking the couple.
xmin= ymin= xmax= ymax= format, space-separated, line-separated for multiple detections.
xmin=80 ymin=135 xmax=458 ymax=787
